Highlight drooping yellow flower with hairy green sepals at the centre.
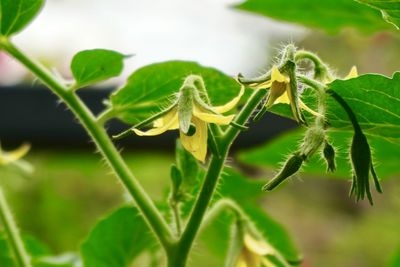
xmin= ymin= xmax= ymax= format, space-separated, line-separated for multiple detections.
xmin=132 ymin=77 xmax=244 ymax=162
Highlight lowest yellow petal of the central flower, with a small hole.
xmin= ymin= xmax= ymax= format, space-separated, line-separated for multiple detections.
xmin=179 ymin=117 xmax=207 ymax=162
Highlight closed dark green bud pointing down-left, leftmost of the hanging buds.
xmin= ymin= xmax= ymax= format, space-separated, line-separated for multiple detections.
xmin=262 ymin=152 xmax=305 ymax=191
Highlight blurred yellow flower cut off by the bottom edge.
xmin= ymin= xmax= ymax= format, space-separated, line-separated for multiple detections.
xmin=235 ymin=234 xmax=275 ymax=267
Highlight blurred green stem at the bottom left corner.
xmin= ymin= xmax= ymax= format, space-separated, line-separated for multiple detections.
xmin=0 ymin=188 xmax=32 ymax=267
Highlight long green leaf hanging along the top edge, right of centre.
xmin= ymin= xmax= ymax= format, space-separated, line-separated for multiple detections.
xmin=236 ymin=0 xmax=390 ymax=33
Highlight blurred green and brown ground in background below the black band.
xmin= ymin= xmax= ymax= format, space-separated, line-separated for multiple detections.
xmin=0 ymin=151 xmax=400 ymax=267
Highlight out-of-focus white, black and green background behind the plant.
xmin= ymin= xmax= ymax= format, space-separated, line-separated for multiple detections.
xmin=0 ymin=0 xmax=400 ymax=267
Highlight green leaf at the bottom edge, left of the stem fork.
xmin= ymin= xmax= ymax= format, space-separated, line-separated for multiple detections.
xmin=81 ymin=207 xmax=155 ymax=267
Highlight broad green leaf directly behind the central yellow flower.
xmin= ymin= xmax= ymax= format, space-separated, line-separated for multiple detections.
xmin=110 ymin=61 xmax=240 ymax=124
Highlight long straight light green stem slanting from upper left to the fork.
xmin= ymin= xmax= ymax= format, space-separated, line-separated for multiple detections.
xmin=1 ymin=40 xmax=174 ymax=251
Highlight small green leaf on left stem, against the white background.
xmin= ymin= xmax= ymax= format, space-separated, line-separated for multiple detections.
xmin=71 ymin=49 xmax=126 ymax=88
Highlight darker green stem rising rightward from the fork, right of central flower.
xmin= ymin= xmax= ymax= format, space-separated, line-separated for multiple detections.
xmin=168 ymin=90 xmax=267 ymax=267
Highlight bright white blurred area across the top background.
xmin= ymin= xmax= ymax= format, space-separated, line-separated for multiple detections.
xmin=0 ymin=0 xmax=304 ymax=84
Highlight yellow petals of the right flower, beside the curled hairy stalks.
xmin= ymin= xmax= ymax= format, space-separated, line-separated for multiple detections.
xmin=250 ymin=66 xmax=320 ymax=121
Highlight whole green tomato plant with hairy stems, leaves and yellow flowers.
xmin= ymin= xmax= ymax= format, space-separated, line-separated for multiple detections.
xmin=0 ymin=0 xmax=400 ymax=267
